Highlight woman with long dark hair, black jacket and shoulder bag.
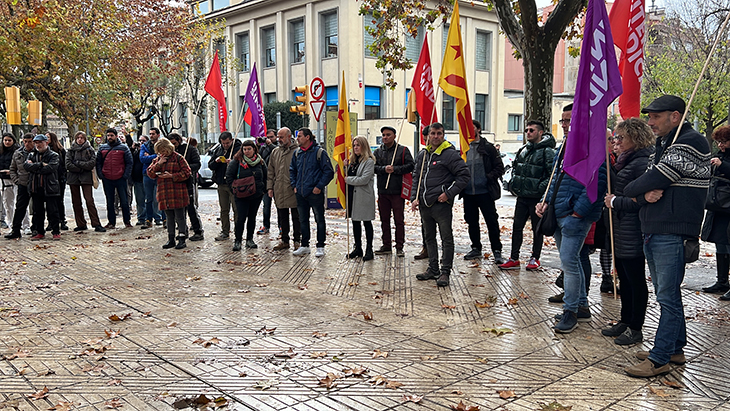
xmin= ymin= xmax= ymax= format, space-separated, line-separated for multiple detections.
xmin=226 ymin=140 xmax=267 ymax=251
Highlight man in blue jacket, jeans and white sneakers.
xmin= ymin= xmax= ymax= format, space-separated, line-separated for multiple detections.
xmin=289 ymin=128 xmax=335 ymax=257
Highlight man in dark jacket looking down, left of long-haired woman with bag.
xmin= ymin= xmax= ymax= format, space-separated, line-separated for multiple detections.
xmin=208 ymin=131 xmax=241 ymax=241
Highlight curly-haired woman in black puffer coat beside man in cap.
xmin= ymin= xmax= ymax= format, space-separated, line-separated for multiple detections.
xmin=601 ymin=118 xmax=656 ymax=345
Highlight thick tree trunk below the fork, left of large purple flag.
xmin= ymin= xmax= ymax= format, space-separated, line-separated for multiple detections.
xmin=522 ymin=41 xmax=555 ymax=126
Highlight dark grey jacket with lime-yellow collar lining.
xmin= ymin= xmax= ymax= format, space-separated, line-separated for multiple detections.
xmin=411 ymin=141 xmax=471 ymax=207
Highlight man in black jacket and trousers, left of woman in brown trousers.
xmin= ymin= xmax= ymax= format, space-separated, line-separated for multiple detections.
xmin=23 ymin=134 xmax=61 ymax=241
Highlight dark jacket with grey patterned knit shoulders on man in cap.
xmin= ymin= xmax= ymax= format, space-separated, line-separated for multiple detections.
xmin=624 ymin=123 xmax=711 ymax=237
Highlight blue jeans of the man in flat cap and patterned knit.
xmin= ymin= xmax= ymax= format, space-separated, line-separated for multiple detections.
xmin=644 ymin=234 xmax=687 ymax=365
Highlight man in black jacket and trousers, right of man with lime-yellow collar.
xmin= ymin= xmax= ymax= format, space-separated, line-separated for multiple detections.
xmin=461 ymin=120 xmax=504 ymax=265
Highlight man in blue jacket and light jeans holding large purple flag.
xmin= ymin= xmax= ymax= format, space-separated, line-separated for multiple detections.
xmin=535 ymin=142 xmax=607 ymax=334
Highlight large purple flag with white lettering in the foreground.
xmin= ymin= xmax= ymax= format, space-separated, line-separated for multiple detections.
xmin=563 ymin=0 xmax=623 ymax=202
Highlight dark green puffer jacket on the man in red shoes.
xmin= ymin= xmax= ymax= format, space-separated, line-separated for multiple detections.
xmin=509 ymin=132 xmax=555 ymax=198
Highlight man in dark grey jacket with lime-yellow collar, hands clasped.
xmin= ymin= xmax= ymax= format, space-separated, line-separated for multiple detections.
xmin=411 ymin=123 xmax=471 ymax=287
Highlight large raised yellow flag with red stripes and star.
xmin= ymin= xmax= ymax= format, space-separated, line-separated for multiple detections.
xmin=439 ymin=1 xmax=474 ymax=161
